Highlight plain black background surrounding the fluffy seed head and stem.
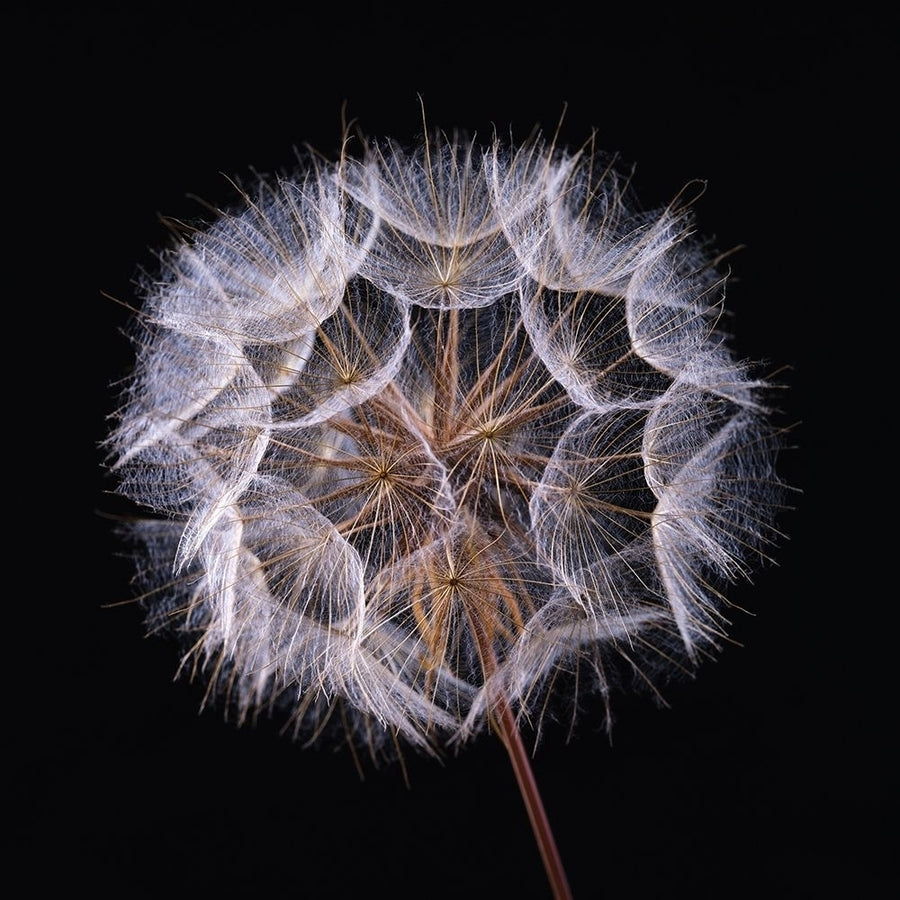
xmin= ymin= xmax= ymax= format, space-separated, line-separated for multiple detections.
xmin=14 ymin=3 xmax=897 ymax=900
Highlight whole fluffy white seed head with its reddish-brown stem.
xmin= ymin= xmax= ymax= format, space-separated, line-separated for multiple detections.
xmin=108 ymin=119 xmax=781 ymax=897
